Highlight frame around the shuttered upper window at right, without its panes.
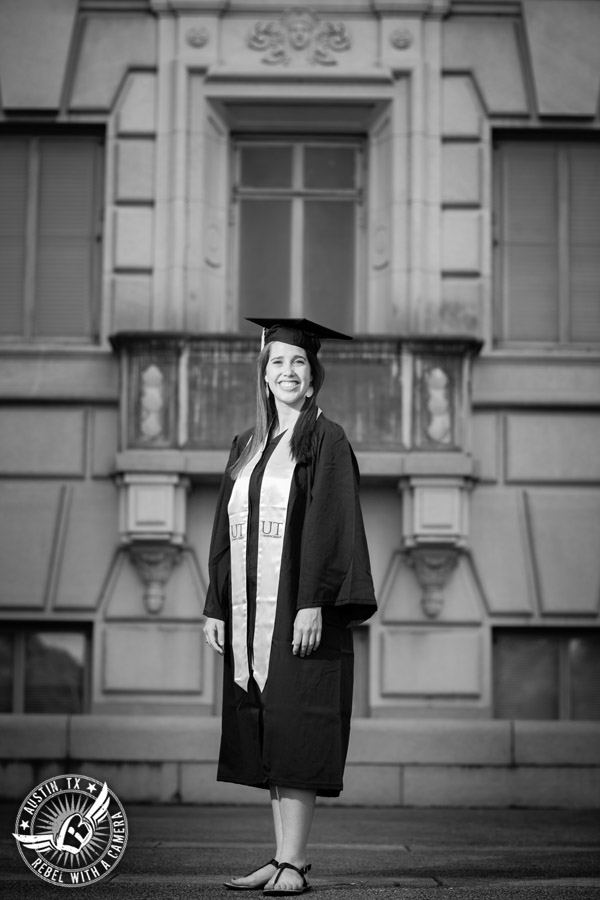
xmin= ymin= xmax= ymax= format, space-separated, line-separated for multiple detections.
xmin=491 ymin=128 xmax=600 ymax=353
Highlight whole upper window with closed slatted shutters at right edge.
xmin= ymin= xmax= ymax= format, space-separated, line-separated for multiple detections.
xmin=494 ymin=136 xmax=600 ymax=346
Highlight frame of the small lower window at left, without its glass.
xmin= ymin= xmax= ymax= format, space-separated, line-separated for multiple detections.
xmin=2 ymin=619 xmax=93 ymax=715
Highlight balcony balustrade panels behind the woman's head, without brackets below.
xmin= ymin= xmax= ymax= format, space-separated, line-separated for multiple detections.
xmin=112 ymin=332 xmax=480 ymax=475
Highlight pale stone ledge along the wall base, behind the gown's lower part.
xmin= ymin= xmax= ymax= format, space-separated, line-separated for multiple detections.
xmin=0 ymin=714 xmax=600 ymax=768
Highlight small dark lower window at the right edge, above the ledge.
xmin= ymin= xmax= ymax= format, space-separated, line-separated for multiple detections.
xmin=493 ymin=628 xmax=600 ymax=719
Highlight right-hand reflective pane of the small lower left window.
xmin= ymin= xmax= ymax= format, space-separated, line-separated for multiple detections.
xmin=25 ymin=632 xmax=85 ymax=713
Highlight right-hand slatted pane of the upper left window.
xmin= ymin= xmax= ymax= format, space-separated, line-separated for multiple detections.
xmin=34 ymin=140 xmax=96 ymax=337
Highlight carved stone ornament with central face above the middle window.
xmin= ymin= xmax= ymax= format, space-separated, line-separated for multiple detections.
xmin=247 ymin=6 xmax=352 ymax=66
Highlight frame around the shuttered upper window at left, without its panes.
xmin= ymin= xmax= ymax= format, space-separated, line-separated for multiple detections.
xmin=0 ymin=122 xmax=106 ymax=349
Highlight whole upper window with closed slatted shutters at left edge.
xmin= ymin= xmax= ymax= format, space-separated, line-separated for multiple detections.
xmin=0 ymin=132 xmax=103 ymax=341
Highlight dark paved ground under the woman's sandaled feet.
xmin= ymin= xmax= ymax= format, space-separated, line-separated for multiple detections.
xmin=0 ymin=803 xmax=600 ymax=900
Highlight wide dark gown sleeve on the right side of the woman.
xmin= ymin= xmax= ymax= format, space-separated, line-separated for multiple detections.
xmin=297 ymin=423 xmax=377 ymax=624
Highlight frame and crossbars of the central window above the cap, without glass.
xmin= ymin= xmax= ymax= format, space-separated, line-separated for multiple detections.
xmin=229 ymin=132 xmax=368 ymax=330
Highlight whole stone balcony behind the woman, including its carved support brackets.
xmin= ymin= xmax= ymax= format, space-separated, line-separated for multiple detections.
xmin=112 ymin=332 xmax=481 ymax=618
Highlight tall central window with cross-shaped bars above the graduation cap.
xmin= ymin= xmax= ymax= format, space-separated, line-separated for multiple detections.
xmin=233 ymin=139 xmax=363 ymax=331
